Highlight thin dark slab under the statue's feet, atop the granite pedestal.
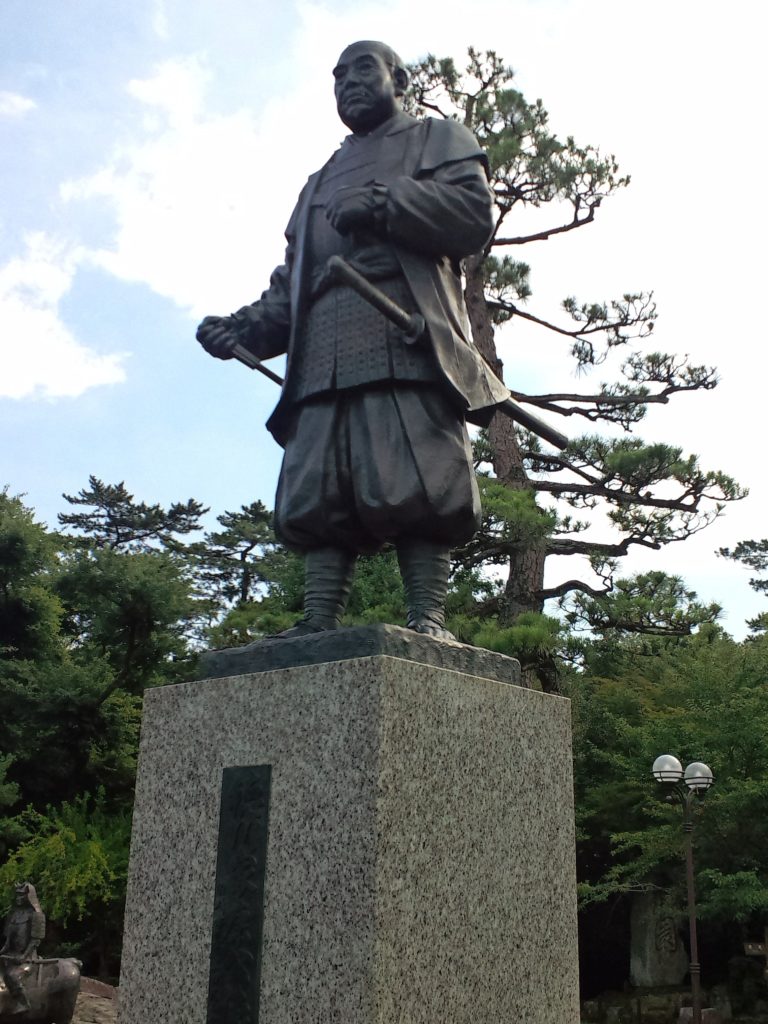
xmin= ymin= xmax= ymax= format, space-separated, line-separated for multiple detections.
xmin=199 ymin=623 xmax=520 ymax=686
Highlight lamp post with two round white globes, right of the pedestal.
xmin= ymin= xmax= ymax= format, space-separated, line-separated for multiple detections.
xmin=651 ymin=754 xmax=715 ymax=1024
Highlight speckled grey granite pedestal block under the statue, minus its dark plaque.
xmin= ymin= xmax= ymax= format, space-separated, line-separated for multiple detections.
xmin=119 ymin=655 xmax=579 ymax=1024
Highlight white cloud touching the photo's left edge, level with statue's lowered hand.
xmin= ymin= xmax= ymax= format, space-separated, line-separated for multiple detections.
xmin=0 ymin=233 xmax=125 ymax=398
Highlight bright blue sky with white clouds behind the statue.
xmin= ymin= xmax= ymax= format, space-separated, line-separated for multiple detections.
xmin=0 ymin=0 xmax=768 ymax=637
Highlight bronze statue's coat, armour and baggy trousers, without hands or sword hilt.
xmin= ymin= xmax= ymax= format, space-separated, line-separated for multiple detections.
xmin=232 ymin=113 xmax=509 ymax=551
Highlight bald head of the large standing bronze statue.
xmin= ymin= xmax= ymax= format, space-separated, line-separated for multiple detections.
xmin=334 ymin=39 xmax=408 ymax=134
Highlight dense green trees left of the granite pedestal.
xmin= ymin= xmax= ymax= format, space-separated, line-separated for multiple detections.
xmin=0 ymin=478 xmax=200 ymax=973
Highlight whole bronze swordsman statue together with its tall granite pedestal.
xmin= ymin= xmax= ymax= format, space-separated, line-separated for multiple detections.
xmin=120 ymin=41 xmax=579 ymax=1024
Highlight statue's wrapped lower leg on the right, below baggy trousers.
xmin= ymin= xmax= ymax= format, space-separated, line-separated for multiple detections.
xmin=397 ymin=538 xmax=456 ymax=640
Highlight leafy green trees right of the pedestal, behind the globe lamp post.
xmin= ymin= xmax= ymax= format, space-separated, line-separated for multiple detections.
xmin=571 ymin=626 xmax=768 ymax=929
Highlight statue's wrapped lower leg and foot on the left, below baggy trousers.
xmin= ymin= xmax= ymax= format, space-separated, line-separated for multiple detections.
xmin=278 ymin=548 xmax=356 ymax=640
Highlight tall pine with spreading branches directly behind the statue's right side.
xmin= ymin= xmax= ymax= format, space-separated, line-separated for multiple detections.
xmin=411 ymin=49 xmax=744 ymax=688
